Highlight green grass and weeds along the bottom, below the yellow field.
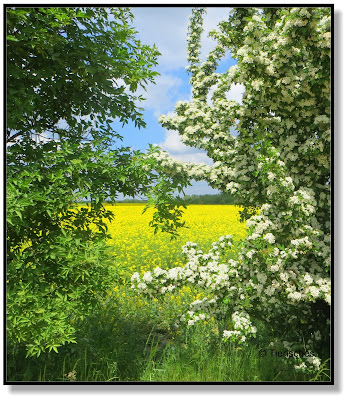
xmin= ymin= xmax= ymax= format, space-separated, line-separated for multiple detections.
xmin=7 ymin=302 xmax=329 ymax=382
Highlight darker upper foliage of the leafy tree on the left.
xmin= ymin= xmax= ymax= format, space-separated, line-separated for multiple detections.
xmin=6 ymin=7 xmax=159 ymax=140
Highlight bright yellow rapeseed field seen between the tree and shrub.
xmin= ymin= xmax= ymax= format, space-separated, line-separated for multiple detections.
xmin=106 ymin=203 xmax=247 ymax=321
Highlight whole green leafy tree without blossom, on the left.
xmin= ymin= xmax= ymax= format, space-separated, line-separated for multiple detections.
xmin=6 ymin=7 xmax=190 ymax=356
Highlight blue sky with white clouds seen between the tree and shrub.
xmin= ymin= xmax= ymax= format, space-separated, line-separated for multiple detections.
xmin=114 ymin=7 xmax=242 ymax=194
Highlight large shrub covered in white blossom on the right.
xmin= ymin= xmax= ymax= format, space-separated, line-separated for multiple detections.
xmin=133 ymin=7 xmax=331 ymax=368
